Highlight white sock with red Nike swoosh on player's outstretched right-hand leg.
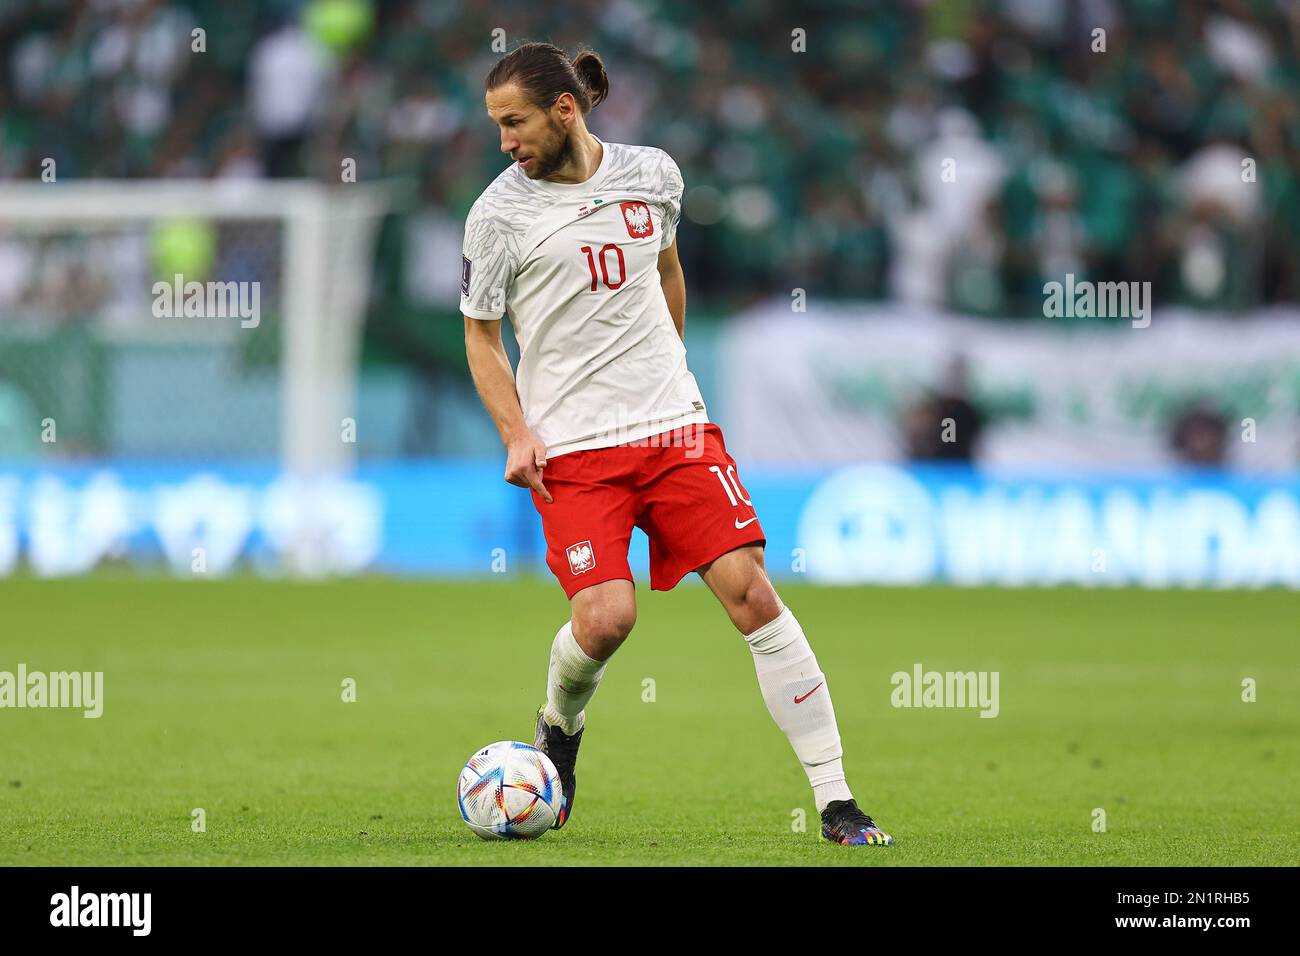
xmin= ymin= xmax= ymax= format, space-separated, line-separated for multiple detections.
xmin=745 ymin=607 xmax=853 ymax=813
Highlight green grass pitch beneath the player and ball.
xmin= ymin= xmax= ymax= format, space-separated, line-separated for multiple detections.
xmin=0 ymin=575 xmax=1300 ymax=866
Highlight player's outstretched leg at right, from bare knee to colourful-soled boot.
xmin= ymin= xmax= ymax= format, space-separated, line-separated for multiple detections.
xmin=699 ymin=545 xmax=893 ymax=845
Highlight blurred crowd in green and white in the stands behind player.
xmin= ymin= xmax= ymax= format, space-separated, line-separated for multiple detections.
xmin=0 ymin=0 xmax=1300 ymax=355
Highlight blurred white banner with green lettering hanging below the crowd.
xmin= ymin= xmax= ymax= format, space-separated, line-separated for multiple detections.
xmin=711 ymin=300 xmax=1300 ymax=473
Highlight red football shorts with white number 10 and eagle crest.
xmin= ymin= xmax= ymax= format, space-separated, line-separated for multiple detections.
xmin=532 ymin=423 xmax=767 ymax=598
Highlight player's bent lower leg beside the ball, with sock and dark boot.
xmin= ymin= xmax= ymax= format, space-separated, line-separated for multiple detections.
xmin=534 ymin=580 xmax=637 ymax=830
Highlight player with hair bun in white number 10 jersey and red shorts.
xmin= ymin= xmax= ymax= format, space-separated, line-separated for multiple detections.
xmin=460 ymin=43 xmax=893 ymax=845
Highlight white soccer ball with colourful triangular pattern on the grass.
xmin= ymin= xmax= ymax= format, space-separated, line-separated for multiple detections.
xmin=456 ymin=740 xmax=564 ymax=840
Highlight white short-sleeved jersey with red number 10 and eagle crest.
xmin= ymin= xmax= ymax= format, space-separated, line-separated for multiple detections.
xmin=460 ymin=142 xmax=709 ymax=458
